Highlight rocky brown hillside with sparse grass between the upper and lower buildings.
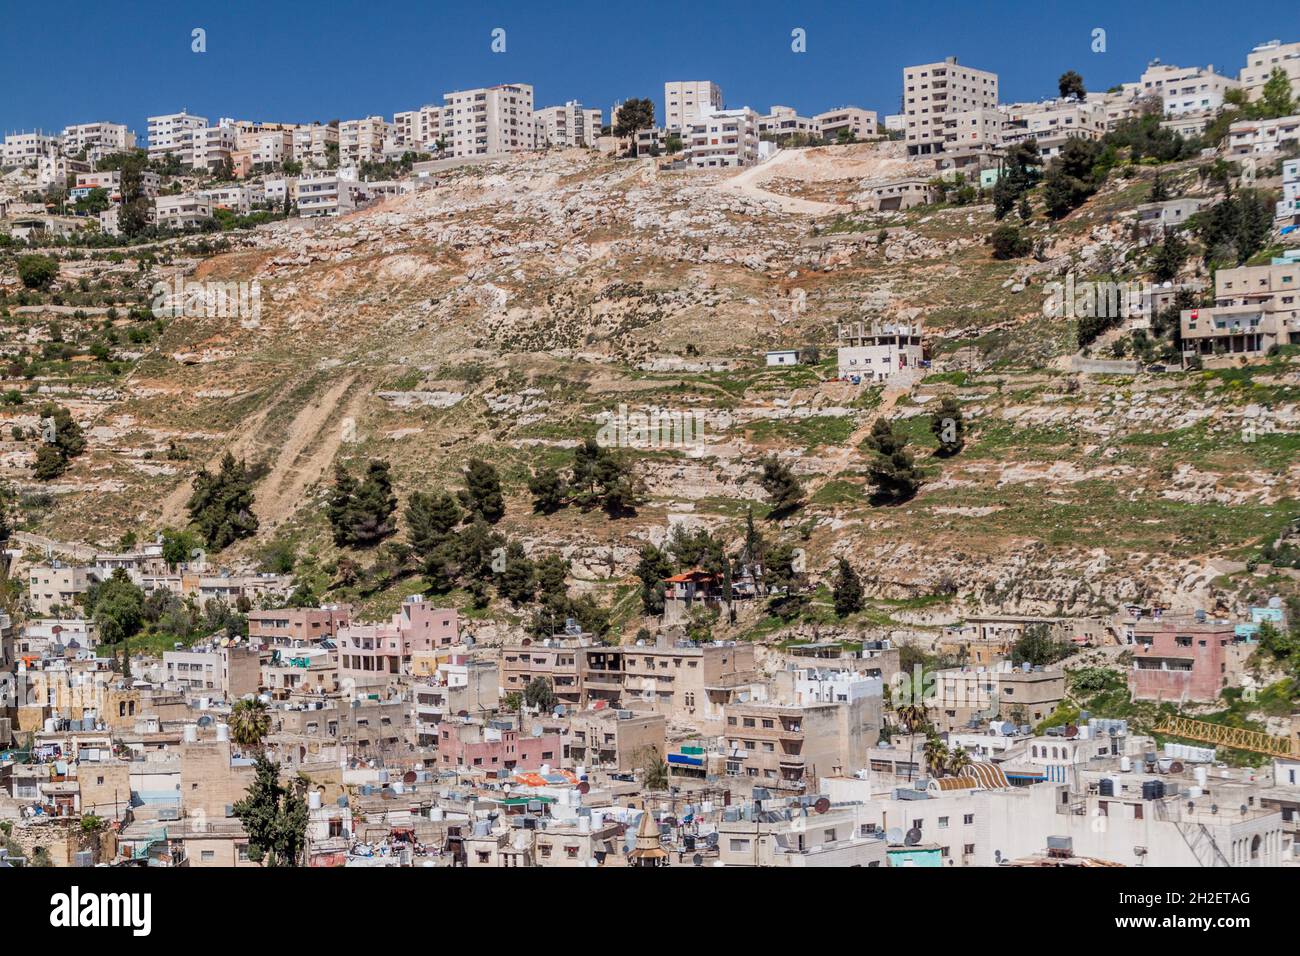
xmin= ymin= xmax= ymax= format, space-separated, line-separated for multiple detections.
xmin=0 ymin=146 xmax=1300 ymax=630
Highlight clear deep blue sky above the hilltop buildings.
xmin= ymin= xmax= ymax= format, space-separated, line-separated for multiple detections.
xmin=0 ymin=0 xmax=1300 ymax=139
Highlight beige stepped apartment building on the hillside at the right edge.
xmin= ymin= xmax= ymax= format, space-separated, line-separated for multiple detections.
xmin=1179 ymin=260 xmax=1300 ymax=358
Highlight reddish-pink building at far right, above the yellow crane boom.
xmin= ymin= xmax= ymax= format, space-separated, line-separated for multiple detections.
xmin=1128 ymin=617 xmax=1242 ymax=701
